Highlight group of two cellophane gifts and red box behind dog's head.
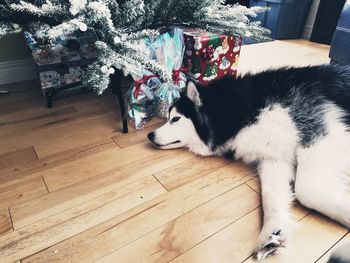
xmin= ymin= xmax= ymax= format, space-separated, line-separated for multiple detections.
xmin=127 ymin=28 xmax=242 ymax=129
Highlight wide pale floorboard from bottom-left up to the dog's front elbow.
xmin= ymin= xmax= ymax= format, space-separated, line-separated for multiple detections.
xmin=21 ymin=164 xmax=252 ymax=263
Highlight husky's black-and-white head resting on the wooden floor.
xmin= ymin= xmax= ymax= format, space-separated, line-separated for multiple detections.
xmin=148 ymin=81 xmax=203 ymax=153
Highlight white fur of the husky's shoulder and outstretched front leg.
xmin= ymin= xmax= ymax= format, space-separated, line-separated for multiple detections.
xmin=226 ymin=104 xmax=298 ymax=259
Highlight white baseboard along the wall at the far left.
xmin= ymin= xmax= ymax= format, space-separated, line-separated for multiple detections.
xmin=0 ymin=59 xmax=37 ymax=85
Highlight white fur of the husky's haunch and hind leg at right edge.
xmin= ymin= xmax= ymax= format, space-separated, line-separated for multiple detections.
xmin=295 ymin=105 xmax=350 ymax=228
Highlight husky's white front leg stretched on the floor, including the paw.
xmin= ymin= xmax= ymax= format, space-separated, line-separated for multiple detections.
xmin=255 ymin=160 xmax=294 ymax=260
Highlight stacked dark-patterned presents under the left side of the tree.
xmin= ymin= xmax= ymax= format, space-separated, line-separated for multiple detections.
xmin=24 ymin=30 xmax=98 ymax=107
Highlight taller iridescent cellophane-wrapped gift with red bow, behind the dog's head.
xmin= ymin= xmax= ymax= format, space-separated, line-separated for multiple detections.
xmin=151 ymin=28 xmax=187 ymax=118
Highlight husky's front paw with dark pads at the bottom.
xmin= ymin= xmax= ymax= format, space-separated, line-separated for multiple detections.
xmin=255 ymin=229 xmax=286 ymax=260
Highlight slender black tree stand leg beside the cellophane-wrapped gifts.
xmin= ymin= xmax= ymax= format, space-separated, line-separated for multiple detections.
xmin=110 ymin=69 xmax=128 ymax=133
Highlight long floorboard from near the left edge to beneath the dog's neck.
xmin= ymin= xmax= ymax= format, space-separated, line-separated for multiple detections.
xmin=10 ymin=151 xmax=191 ymax=229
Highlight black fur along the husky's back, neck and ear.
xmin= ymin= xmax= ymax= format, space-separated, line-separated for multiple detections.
xmin=174 ymin=65 xmax=350 ymax=150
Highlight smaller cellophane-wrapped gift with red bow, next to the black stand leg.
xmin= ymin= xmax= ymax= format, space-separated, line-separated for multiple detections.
xmin=126 ymin=73 xmax=161 ymax=130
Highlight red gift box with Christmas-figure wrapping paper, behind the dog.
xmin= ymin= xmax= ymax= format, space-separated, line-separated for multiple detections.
xmin=183 ymin=29 xmax=242 ymax=85
